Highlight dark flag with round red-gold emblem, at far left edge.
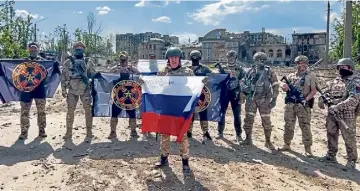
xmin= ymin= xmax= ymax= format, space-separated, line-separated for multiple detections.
xmin=0 ymin=60 xmax=60 ymax=103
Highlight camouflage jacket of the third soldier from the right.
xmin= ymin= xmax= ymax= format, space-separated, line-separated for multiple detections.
xmin=244 ymin=66 xmax=279 ymax=99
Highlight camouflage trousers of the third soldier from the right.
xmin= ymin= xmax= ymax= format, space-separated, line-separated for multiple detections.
xmin=243 ymin=98 xmax=272 ymax=141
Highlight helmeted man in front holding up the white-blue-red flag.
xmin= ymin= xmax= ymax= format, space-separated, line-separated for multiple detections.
xmin=142 ymin=47 xmax=206 ymax=171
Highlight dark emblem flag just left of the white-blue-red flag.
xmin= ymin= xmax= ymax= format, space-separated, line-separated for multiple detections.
xmin=92 ymin=72 xmax=142 ymax=118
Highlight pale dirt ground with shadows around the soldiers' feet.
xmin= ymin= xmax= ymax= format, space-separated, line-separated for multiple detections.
xmin=0 ymin=71 xmax=360 ymax=191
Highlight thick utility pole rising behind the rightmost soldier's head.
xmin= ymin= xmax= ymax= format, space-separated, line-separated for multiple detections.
xmin=343 ymin=1 xmax=353 ymax=58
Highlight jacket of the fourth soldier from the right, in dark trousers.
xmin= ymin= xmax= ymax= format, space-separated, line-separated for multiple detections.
xmin=221 ymin=62 xmax=246 ymax=90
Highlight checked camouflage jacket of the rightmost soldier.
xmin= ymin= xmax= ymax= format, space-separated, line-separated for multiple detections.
xmin=319 ymin=75 xmax=360 ymax=119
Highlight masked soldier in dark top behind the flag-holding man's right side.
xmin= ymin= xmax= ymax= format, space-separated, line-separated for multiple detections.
xmin=187 ymin=50 xmax=212 ymax=143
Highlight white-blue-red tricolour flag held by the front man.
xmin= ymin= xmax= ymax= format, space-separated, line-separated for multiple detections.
xmin=142 ymin=76 xmax=205 ymax=142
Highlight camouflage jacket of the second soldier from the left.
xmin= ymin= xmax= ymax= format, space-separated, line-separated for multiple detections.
xmin=61 ymin=56 xmax=96 ymax=95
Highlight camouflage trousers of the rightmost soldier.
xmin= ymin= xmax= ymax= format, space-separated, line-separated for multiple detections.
xmin=326 ymin=114 xmax=358 ymax=161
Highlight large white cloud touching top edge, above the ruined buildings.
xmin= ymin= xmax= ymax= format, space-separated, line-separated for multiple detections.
xmin=189 ymin=0 xmax=269 ymax=26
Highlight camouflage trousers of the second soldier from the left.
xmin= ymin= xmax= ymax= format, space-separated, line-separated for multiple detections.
xmin=66 ymin=93 xmax=93 ymax=132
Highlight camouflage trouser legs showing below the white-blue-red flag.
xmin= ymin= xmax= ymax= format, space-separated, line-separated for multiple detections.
xmin=160 ymin=134 xmax=190 ymax=159
